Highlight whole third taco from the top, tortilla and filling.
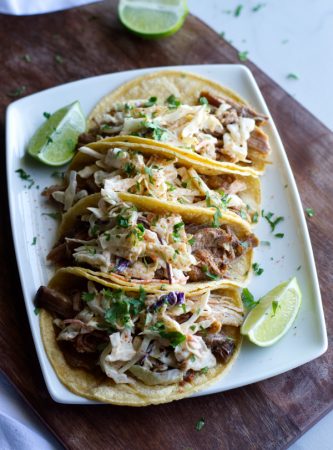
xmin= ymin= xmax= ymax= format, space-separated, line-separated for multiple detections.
xmin=48 ymin=192 xmax=258 ymax=288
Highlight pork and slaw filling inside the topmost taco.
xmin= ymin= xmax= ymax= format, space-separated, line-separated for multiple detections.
xmin=79 ymin=91 xmax=270 ymax=164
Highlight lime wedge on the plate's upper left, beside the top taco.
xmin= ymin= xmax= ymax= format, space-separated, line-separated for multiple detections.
xmin=27 ymin=102 xmax=86 ymax=166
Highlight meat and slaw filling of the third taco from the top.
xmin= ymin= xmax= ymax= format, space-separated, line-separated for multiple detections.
xmin=48 ymin=197 xmax=258 ymax=284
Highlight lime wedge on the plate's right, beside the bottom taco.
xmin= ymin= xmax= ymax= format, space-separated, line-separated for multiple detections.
xmin=241 ymin=278 xmax=302 ymax=347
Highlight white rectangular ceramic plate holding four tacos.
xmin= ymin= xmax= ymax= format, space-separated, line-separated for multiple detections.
xmin=6 ymin=65 xmax=327 ymax=404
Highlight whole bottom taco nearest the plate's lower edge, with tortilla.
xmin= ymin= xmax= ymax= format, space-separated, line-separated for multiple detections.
xmin=35 ymin=268 xmax=243 ymax=406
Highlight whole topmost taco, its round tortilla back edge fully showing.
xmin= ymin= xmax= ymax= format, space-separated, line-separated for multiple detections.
xmin=80 ymin=70 xmax=270 ymax=174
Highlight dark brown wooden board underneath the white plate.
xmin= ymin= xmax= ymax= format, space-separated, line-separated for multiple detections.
xmin=0 ymin=2 xmax=333 ymax=450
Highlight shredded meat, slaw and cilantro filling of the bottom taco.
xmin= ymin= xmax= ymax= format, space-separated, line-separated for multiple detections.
xmin=35 ymin=281 xmax=243 ymax=386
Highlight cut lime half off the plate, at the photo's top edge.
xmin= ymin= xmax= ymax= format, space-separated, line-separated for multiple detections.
xmin=118 ymin=0 xmax=188 ymax=38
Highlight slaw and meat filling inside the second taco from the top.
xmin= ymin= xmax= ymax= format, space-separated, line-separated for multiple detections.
xmin=44 ymin=147 xmax=256 ymax=221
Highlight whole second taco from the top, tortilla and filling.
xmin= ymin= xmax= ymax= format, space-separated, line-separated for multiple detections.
xmin=45 ymin=141 xmax=260 ymax=223
